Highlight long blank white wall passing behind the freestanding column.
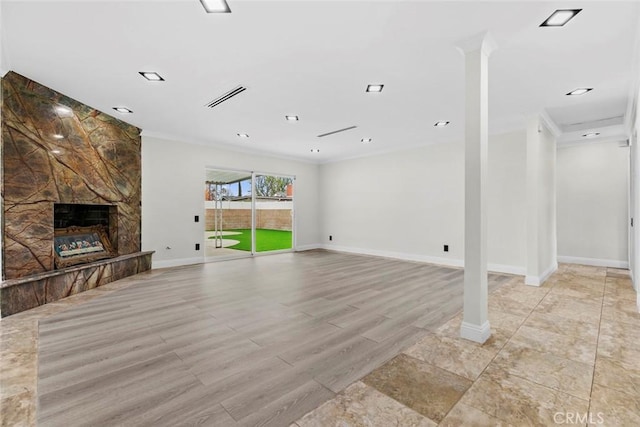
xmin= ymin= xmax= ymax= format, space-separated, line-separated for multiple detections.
xmin=320 ymin=132 xmax=526 ymax=274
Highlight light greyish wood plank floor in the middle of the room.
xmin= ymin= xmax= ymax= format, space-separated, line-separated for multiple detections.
xmin=37 ymin=251 xmax=511 ymax=427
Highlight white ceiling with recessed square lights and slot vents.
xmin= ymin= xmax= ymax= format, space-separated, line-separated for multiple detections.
xmin=0 ymin=0 xmax=640 ymax=162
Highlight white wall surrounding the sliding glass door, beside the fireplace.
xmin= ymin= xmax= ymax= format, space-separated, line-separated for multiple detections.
xmin=142 ymin=135 xmax=320 ymax=268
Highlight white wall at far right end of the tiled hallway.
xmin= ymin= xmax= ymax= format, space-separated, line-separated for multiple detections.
xmin=557 ymin=142 xmax=629 ymax=267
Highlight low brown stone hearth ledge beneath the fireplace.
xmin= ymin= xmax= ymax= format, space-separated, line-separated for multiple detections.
xmin=0 ymin=251 xmax=154 ymax=317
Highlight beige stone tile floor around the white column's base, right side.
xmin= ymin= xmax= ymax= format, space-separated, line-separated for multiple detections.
xmin=293 ymin=265 xmax=640 ymax=427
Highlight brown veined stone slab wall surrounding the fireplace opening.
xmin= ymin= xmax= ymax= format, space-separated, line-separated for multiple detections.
xmin=2 ymin=72 xmax=141 ymax=279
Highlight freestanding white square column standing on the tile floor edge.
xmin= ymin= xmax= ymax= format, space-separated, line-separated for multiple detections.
xmin=458 ymin=32 xmax=495 ymax=343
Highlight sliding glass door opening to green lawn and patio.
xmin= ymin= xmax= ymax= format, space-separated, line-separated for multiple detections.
xmin=204 ymin=168 xmax=295 ymax=261
